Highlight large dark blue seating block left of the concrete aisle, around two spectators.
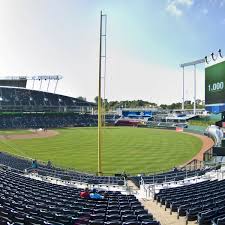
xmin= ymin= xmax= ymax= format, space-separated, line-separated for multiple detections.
xmin=0 ymin=170 xmax=160 ymax=225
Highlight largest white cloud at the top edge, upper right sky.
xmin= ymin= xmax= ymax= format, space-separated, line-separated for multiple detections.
xmin=166 ymin=0 xmax=194 ymax=17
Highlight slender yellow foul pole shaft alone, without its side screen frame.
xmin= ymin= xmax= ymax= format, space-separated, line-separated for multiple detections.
xmin=98 ymin=11 xmax=102 ymax=176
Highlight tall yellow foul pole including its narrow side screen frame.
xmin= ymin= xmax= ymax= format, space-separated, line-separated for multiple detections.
xmin=98 ymin=11 xmax=107 ymax=176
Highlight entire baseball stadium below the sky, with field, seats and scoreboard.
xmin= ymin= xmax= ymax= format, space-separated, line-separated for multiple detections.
xmin=0 ymin=1 xmax=225 ymax=225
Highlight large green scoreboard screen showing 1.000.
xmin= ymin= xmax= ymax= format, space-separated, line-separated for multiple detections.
xmin=205 ymin=61 xmax=225 ymax=113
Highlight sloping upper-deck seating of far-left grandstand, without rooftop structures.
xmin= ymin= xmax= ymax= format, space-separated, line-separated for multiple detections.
xmin=0 ymin=87 xmax=95 ymax=112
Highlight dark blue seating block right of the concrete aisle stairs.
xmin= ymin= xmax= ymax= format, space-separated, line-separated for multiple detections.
xmin=154 ymin=180 xmax=225 ymax=225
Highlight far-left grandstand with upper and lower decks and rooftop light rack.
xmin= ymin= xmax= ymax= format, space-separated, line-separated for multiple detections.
xmin=0 ymin=76 xmax=97 ymax=129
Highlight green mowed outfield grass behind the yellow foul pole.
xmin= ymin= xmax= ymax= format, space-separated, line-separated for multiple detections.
xmin=0 ymin=127 xmax=202 ymax=174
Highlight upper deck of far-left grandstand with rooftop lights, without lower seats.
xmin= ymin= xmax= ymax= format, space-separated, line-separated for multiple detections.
xmin=0 ymin=76 xmax=96 ymax=113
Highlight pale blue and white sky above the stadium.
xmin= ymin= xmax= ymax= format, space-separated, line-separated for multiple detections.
xmin=0 ymin=0 xmax=225 ymax=103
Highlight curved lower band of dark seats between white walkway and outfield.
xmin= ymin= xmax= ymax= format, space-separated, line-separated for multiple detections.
xmin=0 ymin=152 xmax=211 ymax=187
